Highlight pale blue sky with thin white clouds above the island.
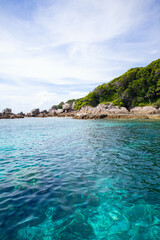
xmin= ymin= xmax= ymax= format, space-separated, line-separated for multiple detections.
xmin=0 ymin=0 xmax=160 ymax=113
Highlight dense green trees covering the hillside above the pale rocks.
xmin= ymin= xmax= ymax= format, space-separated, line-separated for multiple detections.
xmin=74 ymin=59 xmax=160 ymax=110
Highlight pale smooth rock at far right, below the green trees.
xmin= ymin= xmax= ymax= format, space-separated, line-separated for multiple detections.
xmin=130 ymin=106 xmax=160 ymax=114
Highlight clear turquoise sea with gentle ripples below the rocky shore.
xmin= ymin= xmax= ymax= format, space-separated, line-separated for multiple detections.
xmin=0 ymin=118 xmax=160 ymax=240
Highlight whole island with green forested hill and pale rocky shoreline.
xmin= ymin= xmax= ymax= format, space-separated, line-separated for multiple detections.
xmin=0 ymin=59 xmax=160 ymax=119
